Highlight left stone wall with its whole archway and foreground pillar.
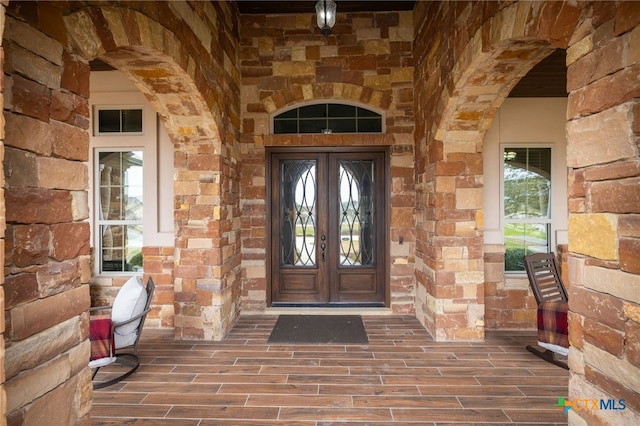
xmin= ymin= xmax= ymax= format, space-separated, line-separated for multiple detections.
xmin=2 ymin=2 xmax=240 ymax=424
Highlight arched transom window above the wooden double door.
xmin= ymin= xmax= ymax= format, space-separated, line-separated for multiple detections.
xmin=273 ymin=103 xmax=382 ymax=135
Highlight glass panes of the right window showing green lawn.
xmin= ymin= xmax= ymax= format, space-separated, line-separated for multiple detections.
xmin=503 ymin=147 xmax=551 ymax=272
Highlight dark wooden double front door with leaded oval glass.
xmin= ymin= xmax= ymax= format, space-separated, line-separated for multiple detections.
xmin=269 ymin=151 xmax=388 ymax=306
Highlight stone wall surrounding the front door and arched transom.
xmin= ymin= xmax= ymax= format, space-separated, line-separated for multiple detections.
xmin=240 ymin=7 xmax=415 ymax=313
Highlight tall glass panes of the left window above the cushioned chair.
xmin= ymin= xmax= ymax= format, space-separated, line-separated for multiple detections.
xmin=97 ymin=151 xmax=143 ymax=272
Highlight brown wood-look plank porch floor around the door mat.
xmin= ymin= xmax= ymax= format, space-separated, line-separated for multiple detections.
xmin=91 ymin=315 xmax=569 ymax=426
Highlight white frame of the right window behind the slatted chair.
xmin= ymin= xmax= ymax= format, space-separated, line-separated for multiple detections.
xmin=499 ymin=142 xmax=558 ymax=276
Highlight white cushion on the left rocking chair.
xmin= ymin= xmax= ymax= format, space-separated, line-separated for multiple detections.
xmin=111 ymin=276 xmax=147 ymax=349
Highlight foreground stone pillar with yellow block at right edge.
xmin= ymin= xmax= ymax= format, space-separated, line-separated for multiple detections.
xmin=567 ymin=2 xmax=640 ymax=424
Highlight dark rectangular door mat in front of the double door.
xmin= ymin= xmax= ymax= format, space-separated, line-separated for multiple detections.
xmin=267 ymin=315 xmax=369 ymax=345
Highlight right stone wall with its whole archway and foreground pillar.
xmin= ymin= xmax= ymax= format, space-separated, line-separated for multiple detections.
xmin=414 ymin=1 xmax=640 ymax=424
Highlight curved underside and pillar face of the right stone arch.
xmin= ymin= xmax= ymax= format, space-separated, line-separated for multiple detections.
xmin=426 ymin=40 xmax=554 ymax=340
